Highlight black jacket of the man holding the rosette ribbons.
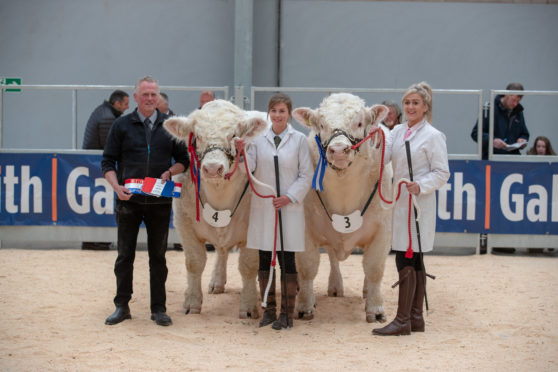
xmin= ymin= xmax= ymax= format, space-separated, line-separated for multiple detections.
xmin=101 ymin=109 xmax=190 ymax=204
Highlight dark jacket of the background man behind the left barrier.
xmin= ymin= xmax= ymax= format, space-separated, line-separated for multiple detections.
xmin=83 ymin=101 xmax=122 ymax=150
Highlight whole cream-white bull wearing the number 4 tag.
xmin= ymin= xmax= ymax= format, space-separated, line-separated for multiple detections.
xmin=164 ymin=100 xmax=267 ymax=318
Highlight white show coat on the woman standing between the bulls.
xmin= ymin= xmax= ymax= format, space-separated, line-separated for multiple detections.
xmin=246 ymin=124 xmax=314 ymax=252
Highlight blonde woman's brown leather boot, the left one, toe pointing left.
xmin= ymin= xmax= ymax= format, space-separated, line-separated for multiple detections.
xmin=372 ymin=266 xmax=417 ymax=336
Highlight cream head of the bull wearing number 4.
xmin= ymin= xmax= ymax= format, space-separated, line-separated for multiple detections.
xmin=163 ymin=100 xmax=267 ymax=182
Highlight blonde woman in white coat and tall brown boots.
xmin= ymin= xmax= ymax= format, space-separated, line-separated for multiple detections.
xmin=372 ymin=82 xmax=450 ymax=336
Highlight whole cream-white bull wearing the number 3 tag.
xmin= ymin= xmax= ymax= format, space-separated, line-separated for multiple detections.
xmin=293 ymin=93 xmax=392 ymax=323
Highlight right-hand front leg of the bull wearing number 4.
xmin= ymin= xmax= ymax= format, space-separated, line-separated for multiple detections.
xmin=238 ymin=247 xmax=260 ymax=319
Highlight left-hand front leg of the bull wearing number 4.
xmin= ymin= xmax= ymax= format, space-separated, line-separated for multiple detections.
xmin=182 ymin=240 xmax=207 ymax=314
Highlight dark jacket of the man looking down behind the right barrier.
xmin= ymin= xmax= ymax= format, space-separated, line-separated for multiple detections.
xmin=471 ymin=96 xmax=529 ymax=159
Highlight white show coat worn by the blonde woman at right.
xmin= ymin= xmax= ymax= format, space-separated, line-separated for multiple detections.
xmin=385 ymin=120 xmax=450 ymax=252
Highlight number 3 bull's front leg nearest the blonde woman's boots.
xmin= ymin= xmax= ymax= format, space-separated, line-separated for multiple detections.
xmin=362 ymin=240 xmax=387 ymax=323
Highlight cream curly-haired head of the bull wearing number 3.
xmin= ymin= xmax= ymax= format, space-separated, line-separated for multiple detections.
xmin=293 ymin=93 xmax=388 ymax=170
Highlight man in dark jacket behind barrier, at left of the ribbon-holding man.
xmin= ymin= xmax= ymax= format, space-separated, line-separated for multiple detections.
xmin=81 ymin=90 xmax=130 ymax=250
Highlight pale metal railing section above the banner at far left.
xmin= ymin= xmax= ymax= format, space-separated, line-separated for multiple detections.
xmin=0 ymin=84 xmax=229 ymax=149
